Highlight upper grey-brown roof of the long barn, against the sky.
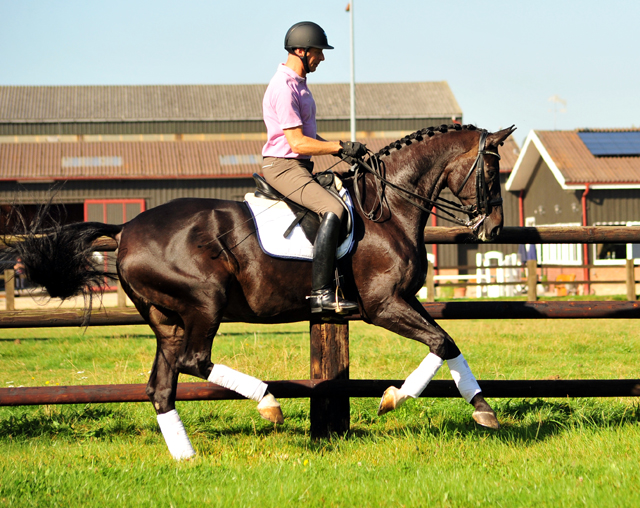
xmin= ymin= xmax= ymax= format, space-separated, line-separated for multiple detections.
xmin=0 ymin=81 xmax=462 ymax=122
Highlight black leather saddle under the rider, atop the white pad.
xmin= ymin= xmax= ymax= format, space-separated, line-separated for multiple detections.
xmin=253 ymin=171 xmax=353 ymax=244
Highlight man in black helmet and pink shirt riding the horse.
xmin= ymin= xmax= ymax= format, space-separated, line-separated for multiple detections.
xmin=262 ymin=21 xmax=367 ymax=313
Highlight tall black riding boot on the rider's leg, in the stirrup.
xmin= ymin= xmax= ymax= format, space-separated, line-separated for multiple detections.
xmin=310 ymin=212 xmax=358 ymax=314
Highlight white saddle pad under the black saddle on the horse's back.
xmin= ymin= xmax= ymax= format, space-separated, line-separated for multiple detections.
xmin=244 ymin=189 xmax=355 ymax=261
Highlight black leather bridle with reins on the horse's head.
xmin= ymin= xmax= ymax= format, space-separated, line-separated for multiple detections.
xmin=351 ymin=130 xmax=502 ymax=231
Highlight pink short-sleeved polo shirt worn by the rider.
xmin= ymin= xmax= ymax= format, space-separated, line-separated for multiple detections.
xmin=262 ymin=64 xmax=317 ymax=159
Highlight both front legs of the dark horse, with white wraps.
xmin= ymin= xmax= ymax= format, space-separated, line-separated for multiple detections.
xmin=372 ymin=297 xmax=500 ymax=429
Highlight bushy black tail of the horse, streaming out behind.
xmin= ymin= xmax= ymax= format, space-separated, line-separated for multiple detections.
xmin=2 ymin=205 xmax=123 ymax=302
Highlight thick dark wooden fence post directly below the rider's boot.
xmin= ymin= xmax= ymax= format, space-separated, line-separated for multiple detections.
xmin=309 ymin=319 xmax=350 ymax=439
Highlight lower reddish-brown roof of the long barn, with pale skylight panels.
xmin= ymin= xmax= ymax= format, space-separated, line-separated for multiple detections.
xmin=0 ymin=138 xmax=395 ymax=181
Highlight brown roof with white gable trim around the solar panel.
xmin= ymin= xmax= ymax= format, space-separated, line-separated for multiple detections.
xmin=506 ymin=129 xmax=640 ymax=191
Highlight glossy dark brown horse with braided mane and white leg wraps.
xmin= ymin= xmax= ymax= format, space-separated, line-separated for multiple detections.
xmin=7 ymin=124 xmax=515 ymax=459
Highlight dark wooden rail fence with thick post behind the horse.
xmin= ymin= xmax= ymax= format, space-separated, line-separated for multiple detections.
xmin=0 ymin=227 xmax=640 ymax=437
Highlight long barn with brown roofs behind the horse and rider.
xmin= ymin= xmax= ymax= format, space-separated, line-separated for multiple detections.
xmin=0 ymin=82 xmax=518 ymax=272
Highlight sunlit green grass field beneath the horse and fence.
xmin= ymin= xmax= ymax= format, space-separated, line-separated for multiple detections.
xmin=0 ymin=320 xmax=640 ymax=507
